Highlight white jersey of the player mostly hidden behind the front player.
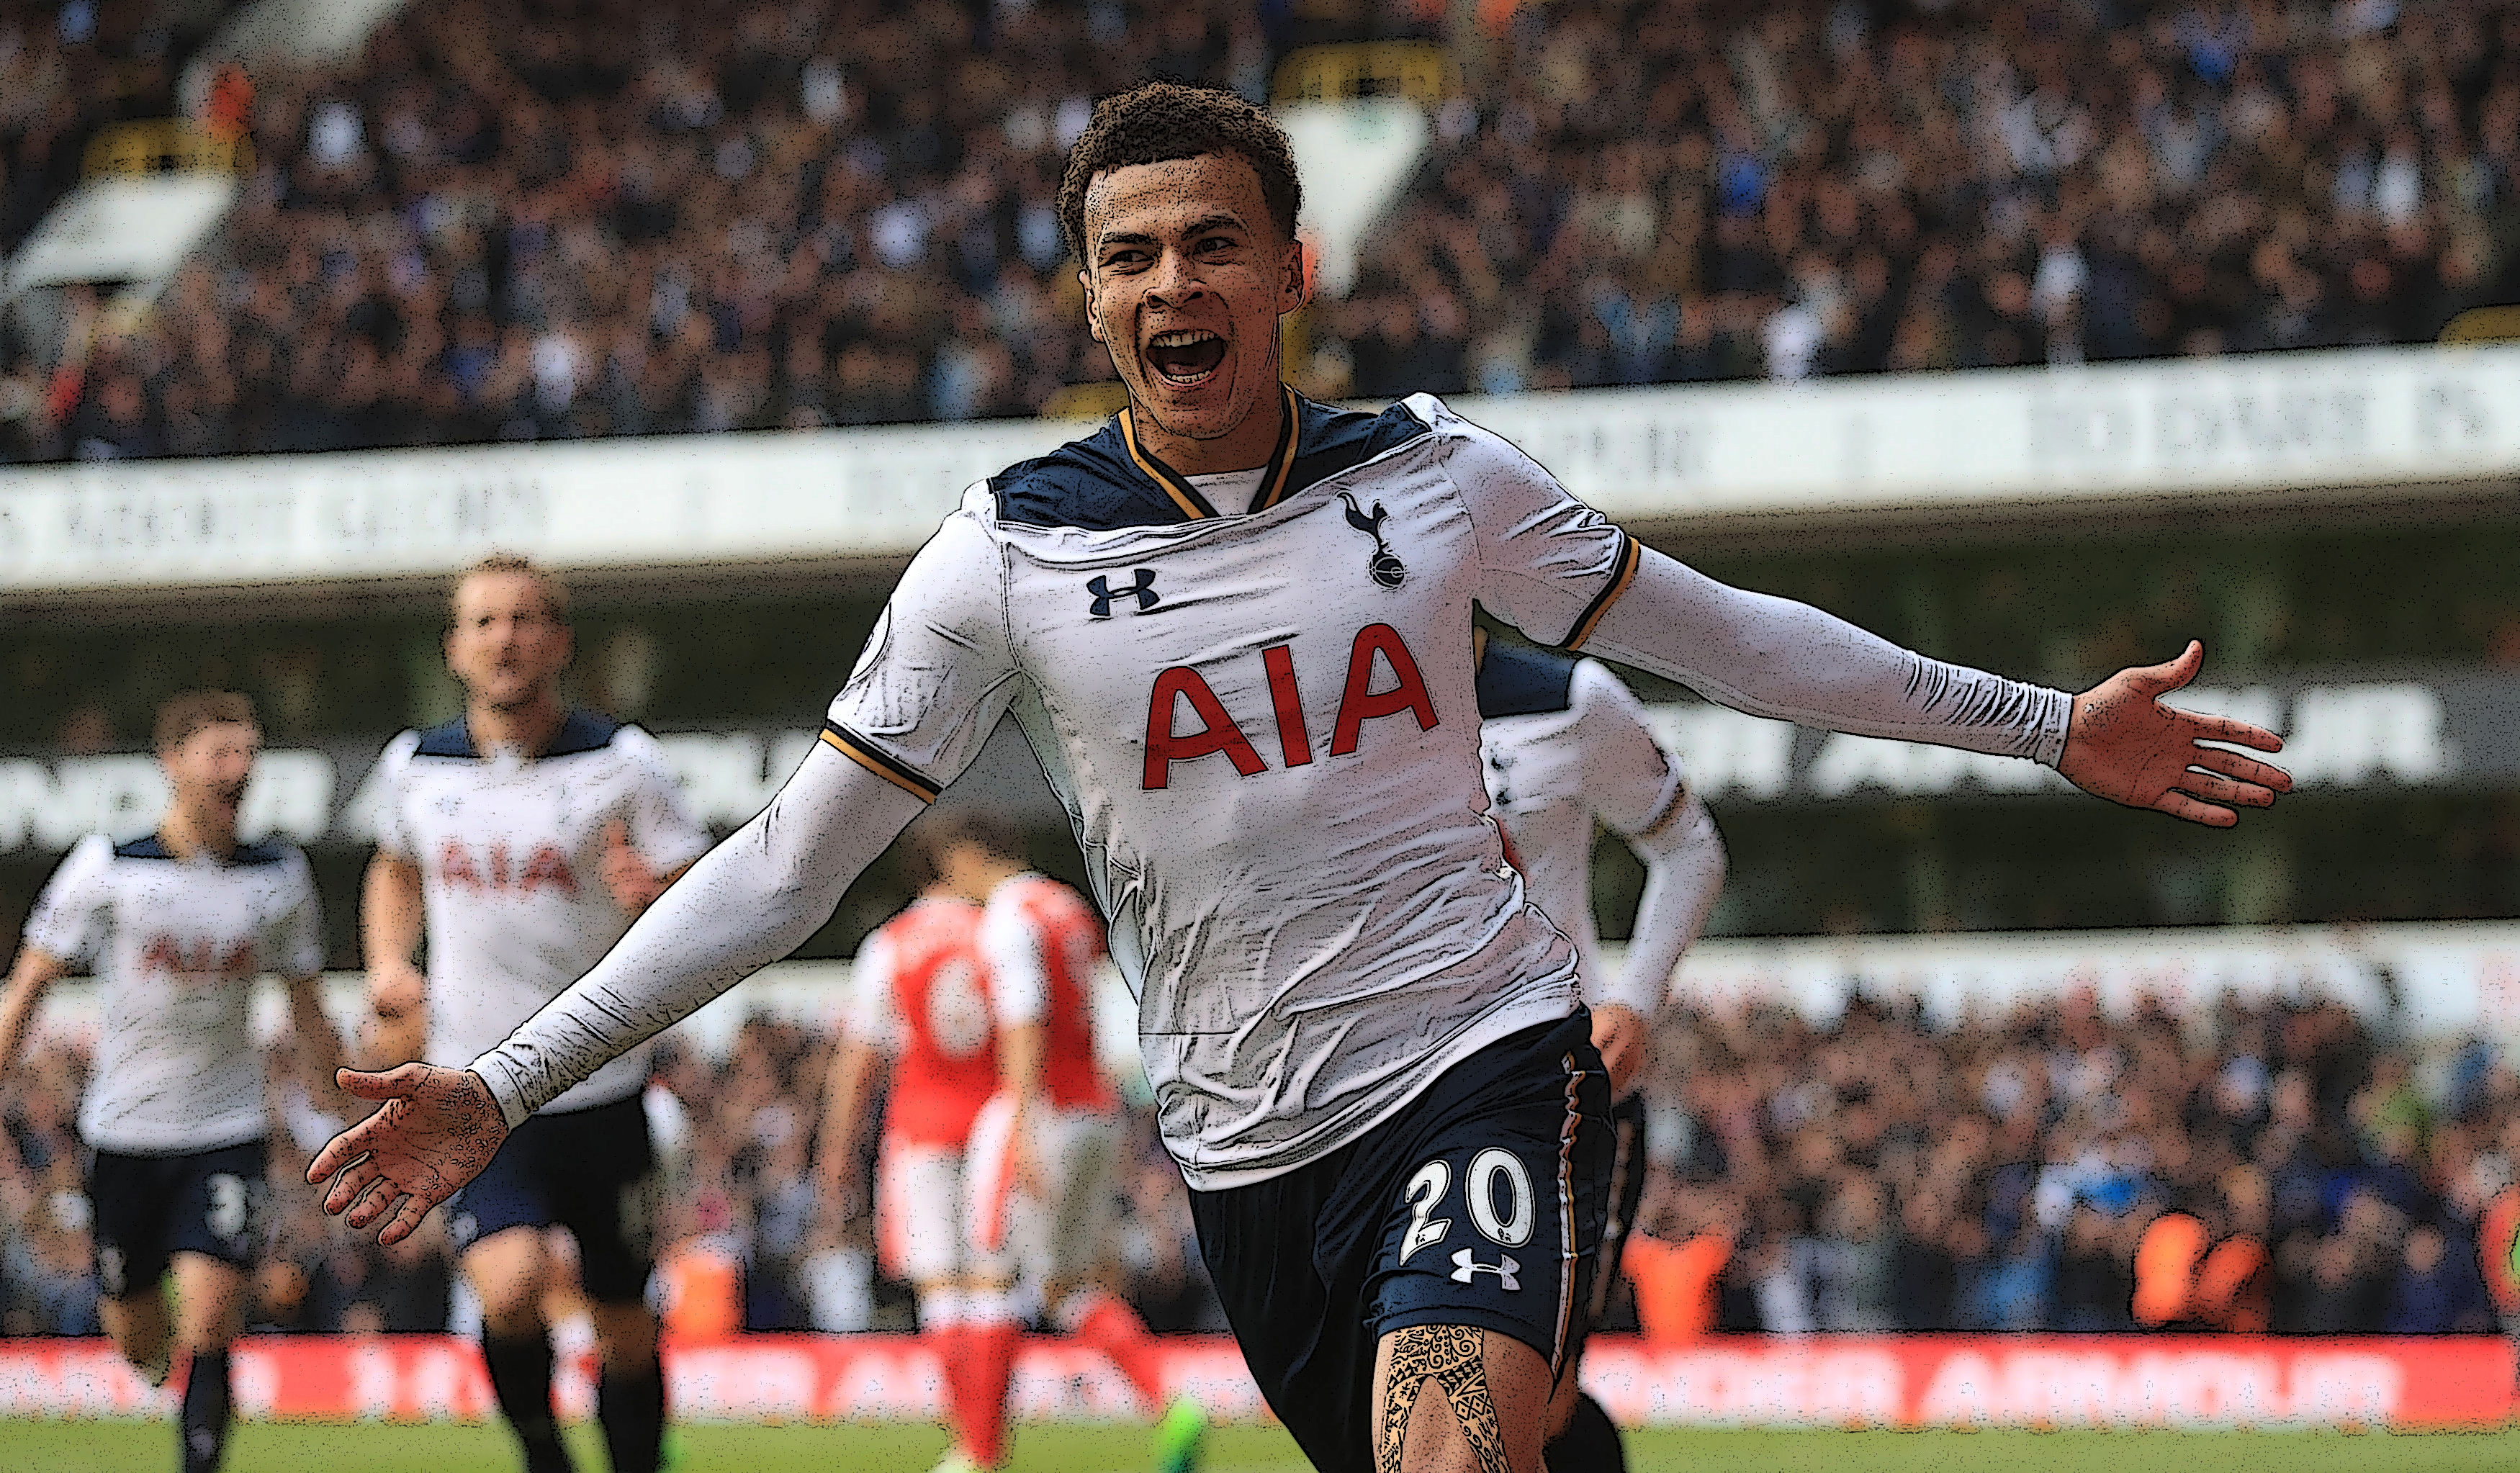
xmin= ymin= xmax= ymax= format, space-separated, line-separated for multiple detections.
xmin=1480 ymin=642 xmax=1688 ymax=1009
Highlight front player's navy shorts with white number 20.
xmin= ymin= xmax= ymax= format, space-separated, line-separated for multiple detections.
xmin=1189 ymin=1012 xmax=1613 ymax=1473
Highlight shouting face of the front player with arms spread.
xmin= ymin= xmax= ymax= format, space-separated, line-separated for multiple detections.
xmin=1081 ymin=153 xmax=1303 ymax=453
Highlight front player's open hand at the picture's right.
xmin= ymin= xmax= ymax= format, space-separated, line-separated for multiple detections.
xmin=2056 ymin=639 xmax=2293 ymax=829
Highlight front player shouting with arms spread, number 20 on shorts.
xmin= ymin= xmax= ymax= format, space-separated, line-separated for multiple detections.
xmin=310 ymin=83 xmax=2291 ymax=1473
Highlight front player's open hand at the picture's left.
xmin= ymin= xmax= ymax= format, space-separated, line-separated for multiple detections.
xmin=307 ymin=1063 xmax=507 ymax=1246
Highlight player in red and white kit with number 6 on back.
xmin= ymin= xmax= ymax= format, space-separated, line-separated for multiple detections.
xmin=819 ymin=821 xmax=1043 ymax=1473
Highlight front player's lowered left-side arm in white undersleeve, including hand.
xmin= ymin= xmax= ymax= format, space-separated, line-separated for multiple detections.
xmin=307 ymin=745 xmax=922 ymax=1244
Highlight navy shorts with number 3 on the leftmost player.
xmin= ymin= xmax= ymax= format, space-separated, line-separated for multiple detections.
xmin=89 ymin=1140 xmax=270 ymax=1299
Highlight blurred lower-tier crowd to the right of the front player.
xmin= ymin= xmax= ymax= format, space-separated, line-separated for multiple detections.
xmin=1636 ymin=997 xmax=2520 ymax=1335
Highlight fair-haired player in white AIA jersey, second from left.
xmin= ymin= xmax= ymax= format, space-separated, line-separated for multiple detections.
xmin=361 ymin=557 xmax=708 ymax=1473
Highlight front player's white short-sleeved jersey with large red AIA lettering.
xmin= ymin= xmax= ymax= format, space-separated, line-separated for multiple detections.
xmin=824 ymin=395 xmax=1638 ymax=1189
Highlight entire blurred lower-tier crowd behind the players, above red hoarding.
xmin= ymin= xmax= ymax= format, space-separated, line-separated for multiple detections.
xmin=0 ymin=982 xmax=2520 ymax=1337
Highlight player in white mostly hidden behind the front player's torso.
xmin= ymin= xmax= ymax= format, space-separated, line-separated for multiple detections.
xmin=1477 ymin=629 xmax=1724 ymax=1471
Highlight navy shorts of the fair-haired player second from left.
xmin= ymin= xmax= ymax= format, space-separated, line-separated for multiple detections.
xmin=446 ymin=1095 xmax=655 ymax=1305
